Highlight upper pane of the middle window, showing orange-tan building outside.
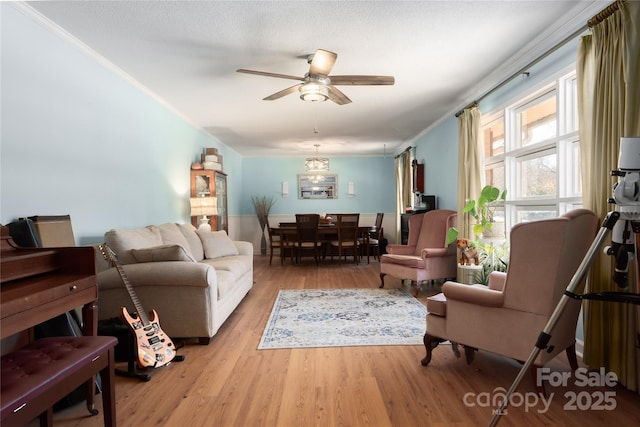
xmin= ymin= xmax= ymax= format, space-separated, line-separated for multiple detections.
xmin=519 ymin=95 xmax=557 ymax=147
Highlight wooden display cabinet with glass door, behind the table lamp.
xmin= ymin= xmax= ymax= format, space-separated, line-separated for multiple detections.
xmin=191 ymin=169 xmax=229 ymax=233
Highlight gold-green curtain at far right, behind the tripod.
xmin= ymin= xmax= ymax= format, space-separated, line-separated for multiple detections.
xmin=576 ymin=2 xmax=640 ymax=391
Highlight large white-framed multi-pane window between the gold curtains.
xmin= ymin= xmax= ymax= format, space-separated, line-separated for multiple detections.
xmin=482 ymin=71 xmax=582 ymax=236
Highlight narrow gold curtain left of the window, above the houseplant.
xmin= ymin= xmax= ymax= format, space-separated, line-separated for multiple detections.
xmin=458 ymin=106 xmax=483 ymax=238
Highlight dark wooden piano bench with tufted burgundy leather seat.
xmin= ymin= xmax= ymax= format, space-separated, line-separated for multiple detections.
xmin=0 ymin=336 xmax=118 ymax=427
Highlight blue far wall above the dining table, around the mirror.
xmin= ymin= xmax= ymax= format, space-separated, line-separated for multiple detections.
xmin=241 ymin=157 xmax=395 ymax=215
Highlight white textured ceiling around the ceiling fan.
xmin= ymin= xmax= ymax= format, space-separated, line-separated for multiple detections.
xmin=22 ymin=0 xmax=608 ymax=156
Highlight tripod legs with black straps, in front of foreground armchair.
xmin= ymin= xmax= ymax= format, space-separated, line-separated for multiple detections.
xmin=489 ymin=211 xmax=640 ymax=427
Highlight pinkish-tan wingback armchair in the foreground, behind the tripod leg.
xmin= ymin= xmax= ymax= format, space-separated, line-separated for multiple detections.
xmin=422 ymin=209 xmax=598 ymax=391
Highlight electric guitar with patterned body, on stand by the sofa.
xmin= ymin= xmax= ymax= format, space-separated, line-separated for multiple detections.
xmin=99 ymin=243 xmax=176 ymax=368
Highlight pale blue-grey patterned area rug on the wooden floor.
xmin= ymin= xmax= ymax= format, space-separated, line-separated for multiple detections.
xmin=258 ymin=288 xmax=427 ymax=349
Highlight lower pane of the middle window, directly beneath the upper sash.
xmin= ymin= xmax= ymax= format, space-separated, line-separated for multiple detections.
xmin=517 ymin=153 xmax=558 ymax=197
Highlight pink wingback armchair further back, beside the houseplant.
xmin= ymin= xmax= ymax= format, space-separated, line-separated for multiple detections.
xmin=380 ymin=209 xmax=457 ymax=294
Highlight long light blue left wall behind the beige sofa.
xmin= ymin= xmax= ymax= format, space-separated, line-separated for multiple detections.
xmin=0 ymin=3 xmax=242 ymax=244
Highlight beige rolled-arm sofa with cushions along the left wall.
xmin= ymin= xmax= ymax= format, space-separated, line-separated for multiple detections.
xmin=97 ymin=223 xmax=253 ymax=344
